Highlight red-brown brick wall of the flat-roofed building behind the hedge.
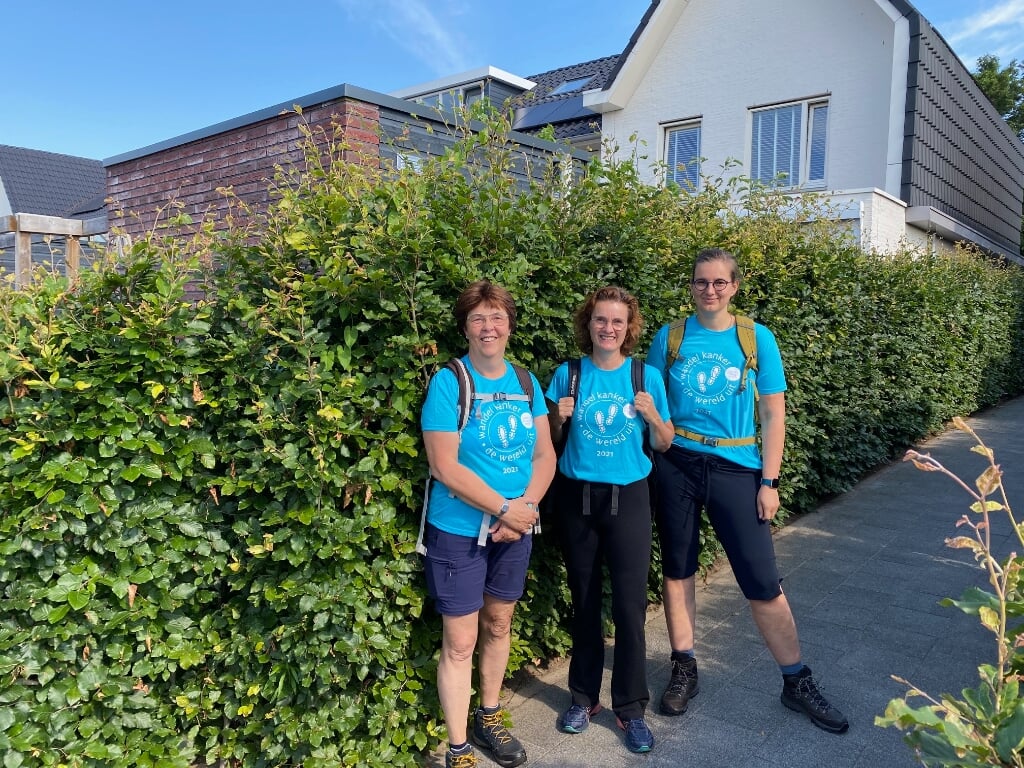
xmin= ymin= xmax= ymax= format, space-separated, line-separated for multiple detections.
xmin=106 ymin=98 xmax=380 ymax=238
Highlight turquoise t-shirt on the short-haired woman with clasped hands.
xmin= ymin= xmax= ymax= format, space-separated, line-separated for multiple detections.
xmin=420 ymin=355 xmax=548 ymax=539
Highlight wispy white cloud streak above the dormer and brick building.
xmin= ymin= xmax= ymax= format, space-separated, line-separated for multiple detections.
xmin=338 ymin=0 xmax=471 ymax=77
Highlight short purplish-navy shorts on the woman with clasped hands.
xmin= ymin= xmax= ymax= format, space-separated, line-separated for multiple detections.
xmin=423 ymin=523 xmax=534 ymax=616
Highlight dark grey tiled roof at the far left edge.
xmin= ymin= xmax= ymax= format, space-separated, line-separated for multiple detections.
xmin=0 ymin=144 xmax=106 ymax=218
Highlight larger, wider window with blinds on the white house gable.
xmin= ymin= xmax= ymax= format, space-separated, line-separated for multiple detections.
xmin=751 ymin=101 xmax=828 ymax=186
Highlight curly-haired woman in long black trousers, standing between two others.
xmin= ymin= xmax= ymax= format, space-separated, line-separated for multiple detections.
xmin=547 ymin=286 xmax=673 ymax=753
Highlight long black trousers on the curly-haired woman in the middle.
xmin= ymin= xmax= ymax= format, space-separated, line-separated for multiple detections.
xmin=554 ymin=474 xmax=651 ymax=720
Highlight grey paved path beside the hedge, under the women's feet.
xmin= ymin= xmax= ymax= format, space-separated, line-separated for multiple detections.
xmin=441 ymin=398 xmax=1024 ymax=768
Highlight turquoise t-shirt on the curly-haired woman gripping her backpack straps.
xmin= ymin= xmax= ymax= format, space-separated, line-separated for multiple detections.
xmin=547 ymin=357 xmax=669 ymax=485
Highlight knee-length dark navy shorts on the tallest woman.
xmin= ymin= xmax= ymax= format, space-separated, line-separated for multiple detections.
xmin=654 ymin=445 xmax=782 ymax=600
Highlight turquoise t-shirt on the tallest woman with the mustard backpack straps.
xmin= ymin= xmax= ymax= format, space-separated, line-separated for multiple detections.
xmin=647 ymin=315 xmax=786 ymax=469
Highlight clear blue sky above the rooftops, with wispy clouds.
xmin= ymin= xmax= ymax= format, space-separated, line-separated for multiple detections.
xmin=0 ymin=0 xmax=1024 ymax=160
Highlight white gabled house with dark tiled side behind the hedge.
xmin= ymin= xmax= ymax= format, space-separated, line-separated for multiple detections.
xmin=581 ymin=0 xmax=1024 ymax=261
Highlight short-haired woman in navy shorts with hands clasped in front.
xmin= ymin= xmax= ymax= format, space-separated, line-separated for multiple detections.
xmin=421 ymin=281 xmax=555 ymax=768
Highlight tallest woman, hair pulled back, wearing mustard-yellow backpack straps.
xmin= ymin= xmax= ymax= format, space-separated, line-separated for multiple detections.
xmin=647 ymin=248 xmax=849 ymax=733
